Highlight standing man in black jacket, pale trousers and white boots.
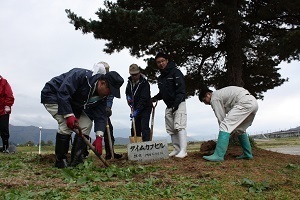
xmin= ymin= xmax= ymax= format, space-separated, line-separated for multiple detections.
xmin=152 ymin=53 xmax=187 ymax=158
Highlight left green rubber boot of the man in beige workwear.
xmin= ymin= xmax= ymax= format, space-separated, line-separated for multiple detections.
xmin=203 ymin=131 xmax=230 ymax=162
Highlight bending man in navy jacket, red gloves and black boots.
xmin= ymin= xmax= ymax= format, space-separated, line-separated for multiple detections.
xmin=41 ymin=68 xmax=124 ymax=168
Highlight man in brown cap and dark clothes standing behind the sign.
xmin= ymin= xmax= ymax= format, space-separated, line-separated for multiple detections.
xmin=125 ymin=64 xmax=152 ymax=142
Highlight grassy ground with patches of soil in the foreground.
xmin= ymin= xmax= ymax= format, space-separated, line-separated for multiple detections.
xmin=0 ymin=138 xmax=300 ymax=200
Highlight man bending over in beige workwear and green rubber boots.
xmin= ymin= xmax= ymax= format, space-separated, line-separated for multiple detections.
xmin=199 ymin=86 xmax=258 ymax=162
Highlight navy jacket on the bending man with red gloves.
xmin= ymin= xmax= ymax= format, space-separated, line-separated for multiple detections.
xmin=41 ymin=68 xmax=107 ymax=132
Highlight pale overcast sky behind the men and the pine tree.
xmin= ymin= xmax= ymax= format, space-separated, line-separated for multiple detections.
xmin=0 ymin=0 xmax=300 ymax=140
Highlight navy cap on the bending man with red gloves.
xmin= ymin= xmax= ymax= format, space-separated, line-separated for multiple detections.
xmin=105 ymin=71 xmax=124 ymax=98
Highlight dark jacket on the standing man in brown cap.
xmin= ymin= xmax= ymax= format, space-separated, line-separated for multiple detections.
xmin=125 ymin=74 xmax=152 ymax=112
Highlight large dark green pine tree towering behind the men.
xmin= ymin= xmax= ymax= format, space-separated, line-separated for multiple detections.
xmin=66 ymin=0 xmax=300 ymax=99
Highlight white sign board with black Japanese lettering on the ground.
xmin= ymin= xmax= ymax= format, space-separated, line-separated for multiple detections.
xmin=127 ymin=140 xmax=169 ymax=162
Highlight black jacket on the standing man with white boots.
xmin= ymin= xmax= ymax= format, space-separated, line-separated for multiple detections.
xmin=155 ymin=61 xmax=186 ymax=108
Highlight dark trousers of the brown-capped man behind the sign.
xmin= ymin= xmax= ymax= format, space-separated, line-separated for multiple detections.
xmin=131 ymin=109 xmax=151 ymax=142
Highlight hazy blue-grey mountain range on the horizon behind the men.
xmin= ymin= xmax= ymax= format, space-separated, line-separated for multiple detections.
xmin=9 ymin=124 xmax=197 ymax=145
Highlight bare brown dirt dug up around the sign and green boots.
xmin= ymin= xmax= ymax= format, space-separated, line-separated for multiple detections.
xmin=32 ymin=145 xmax=300 ymax=178
